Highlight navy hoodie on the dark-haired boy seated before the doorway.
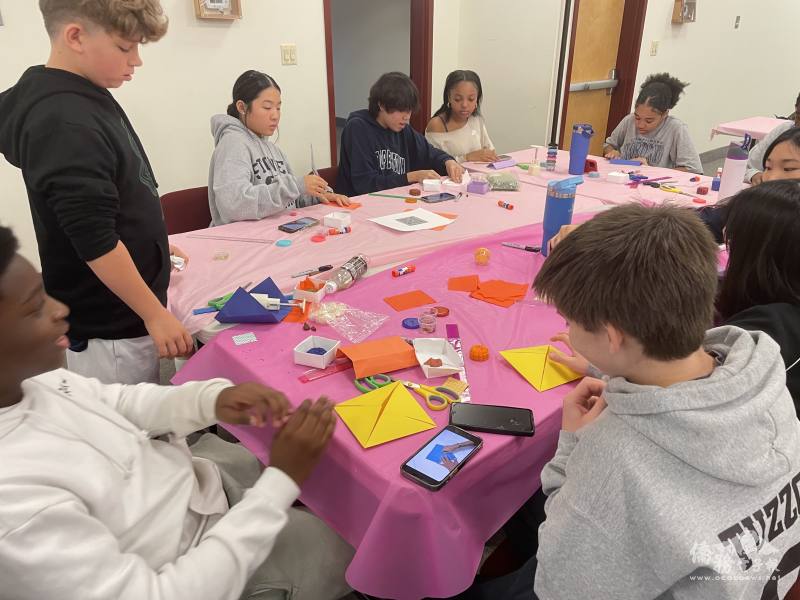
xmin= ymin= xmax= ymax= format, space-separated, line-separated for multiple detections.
xmin=336 ymin=110 xmax=453 ymax=196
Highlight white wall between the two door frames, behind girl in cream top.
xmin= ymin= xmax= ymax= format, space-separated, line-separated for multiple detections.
xmin=433 ymin=0 xmax=563 ymax=152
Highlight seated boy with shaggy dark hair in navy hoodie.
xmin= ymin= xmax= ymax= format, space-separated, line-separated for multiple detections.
xmin=336 ymin=72 xmax=464 ymax=196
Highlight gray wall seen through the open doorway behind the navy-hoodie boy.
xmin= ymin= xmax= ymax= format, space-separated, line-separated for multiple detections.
xmin=331 ymin=0 xmax=411 ymax=119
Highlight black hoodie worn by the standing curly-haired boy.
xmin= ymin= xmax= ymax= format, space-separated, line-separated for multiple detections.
xmin=0 ymin=66 xmax=170 ymax=340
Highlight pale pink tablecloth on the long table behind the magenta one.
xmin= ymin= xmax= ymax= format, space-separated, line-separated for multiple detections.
xmin=169 ymin=179 xmax=608 ymax=341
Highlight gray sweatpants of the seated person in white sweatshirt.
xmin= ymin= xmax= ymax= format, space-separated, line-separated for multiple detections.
xmin=191 ymin=434 xmax=353 ymax=600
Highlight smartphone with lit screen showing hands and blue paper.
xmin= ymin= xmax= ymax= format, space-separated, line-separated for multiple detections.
xmin=400 ymin=425 xmax=483 ymax=491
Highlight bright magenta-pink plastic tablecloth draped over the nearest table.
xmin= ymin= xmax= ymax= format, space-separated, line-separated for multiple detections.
xmin=173 ymin=220 xmax=585 ymax=600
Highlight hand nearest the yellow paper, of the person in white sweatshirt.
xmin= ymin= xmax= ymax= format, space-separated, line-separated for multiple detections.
xmin=270 ymin=397 xmax=336 ymax=486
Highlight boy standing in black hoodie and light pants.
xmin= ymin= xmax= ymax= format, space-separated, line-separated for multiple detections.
xmin=0 ymin=0 xmax=192 ymax=383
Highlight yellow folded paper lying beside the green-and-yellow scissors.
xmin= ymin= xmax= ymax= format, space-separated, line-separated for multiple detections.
xmin=335 ymin=381 xmax=436 ymax=448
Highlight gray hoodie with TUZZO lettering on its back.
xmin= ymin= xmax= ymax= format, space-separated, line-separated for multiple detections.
xmin=535 ymin=326 xmax=800 ymax=600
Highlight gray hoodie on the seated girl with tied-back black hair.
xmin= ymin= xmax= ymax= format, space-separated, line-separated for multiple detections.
xmin=208 ymin=115 xmax=319 ymax=227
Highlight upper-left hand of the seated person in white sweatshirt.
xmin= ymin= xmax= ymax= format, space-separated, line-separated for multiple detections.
xmin=216 ymin=383 xmax=289 ymax=429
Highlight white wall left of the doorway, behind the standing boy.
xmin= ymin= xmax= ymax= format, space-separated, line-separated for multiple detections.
xmin=0 ymin=0 xmax=332 ymax=264
